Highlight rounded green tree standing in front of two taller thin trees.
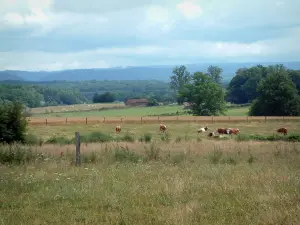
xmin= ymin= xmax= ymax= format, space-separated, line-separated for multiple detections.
xmin=180 ymin=72 xmax=226 ymax=116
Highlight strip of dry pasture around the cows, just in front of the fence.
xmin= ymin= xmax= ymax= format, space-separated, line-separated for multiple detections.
xmin=29 ymin=121 xmax=300 ymax=140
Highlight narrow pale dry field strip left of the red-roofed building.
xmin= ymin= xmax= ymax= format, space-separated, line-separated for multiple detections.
xmin=31 ymin=103 xmax=125 ymax=114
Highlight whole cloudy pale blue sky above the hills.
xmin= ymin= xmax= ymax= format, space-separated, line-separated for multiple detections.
xmin=0 ymin=0 xmax=300 ymax=71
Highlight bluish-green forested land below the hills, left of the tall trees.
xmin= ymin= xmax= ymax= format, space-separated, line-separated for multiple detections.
xmin=0 ymin=80 xmax=174 ymax=107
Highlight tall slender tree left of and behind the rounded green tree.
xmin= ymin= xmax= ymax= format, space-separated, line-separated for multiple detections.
xmin=170 ymin=65 xmax=191 ymax=104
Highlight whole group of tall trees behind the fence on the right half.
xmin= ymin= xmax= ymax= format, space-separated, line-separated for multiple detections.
xmin=170 ymin=64 xmax=300 ymax=116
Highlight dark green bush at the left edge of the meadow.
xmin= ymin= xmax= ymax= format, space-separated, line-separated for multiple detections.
xmin=0 ymin=102 xmax=28 ymax=144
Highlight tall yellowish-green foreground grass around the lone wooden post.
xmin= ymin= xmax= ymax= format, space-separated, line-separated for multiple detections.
xmin=0 ymin=141 xmax=300 ymax=225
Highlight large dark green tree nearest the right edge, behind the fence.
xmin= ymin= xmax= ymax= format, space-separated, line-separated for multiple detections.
xmin=249 ymin=68 xmax=300 ymax=116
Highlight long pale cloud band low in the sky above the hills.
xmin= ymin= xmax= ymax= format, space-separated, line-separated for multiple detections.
xmin=0 ymin=31 xmax=300 ymax=70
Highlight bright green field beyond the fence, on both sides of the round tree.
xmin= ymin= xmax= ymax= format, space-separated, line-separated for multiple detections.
xmin=32 ymin=104 xmax=249 ymax=118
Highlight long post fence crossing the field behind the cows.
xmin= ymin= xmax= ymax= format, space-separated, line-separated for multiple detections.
xmin=28 ymin=116 xmax=300 ymax=126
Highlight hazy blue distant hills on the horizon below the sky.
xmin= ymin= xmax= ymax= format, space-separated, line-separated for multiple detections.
xmin=0 ymin=62 xmax=300 ymax=81
